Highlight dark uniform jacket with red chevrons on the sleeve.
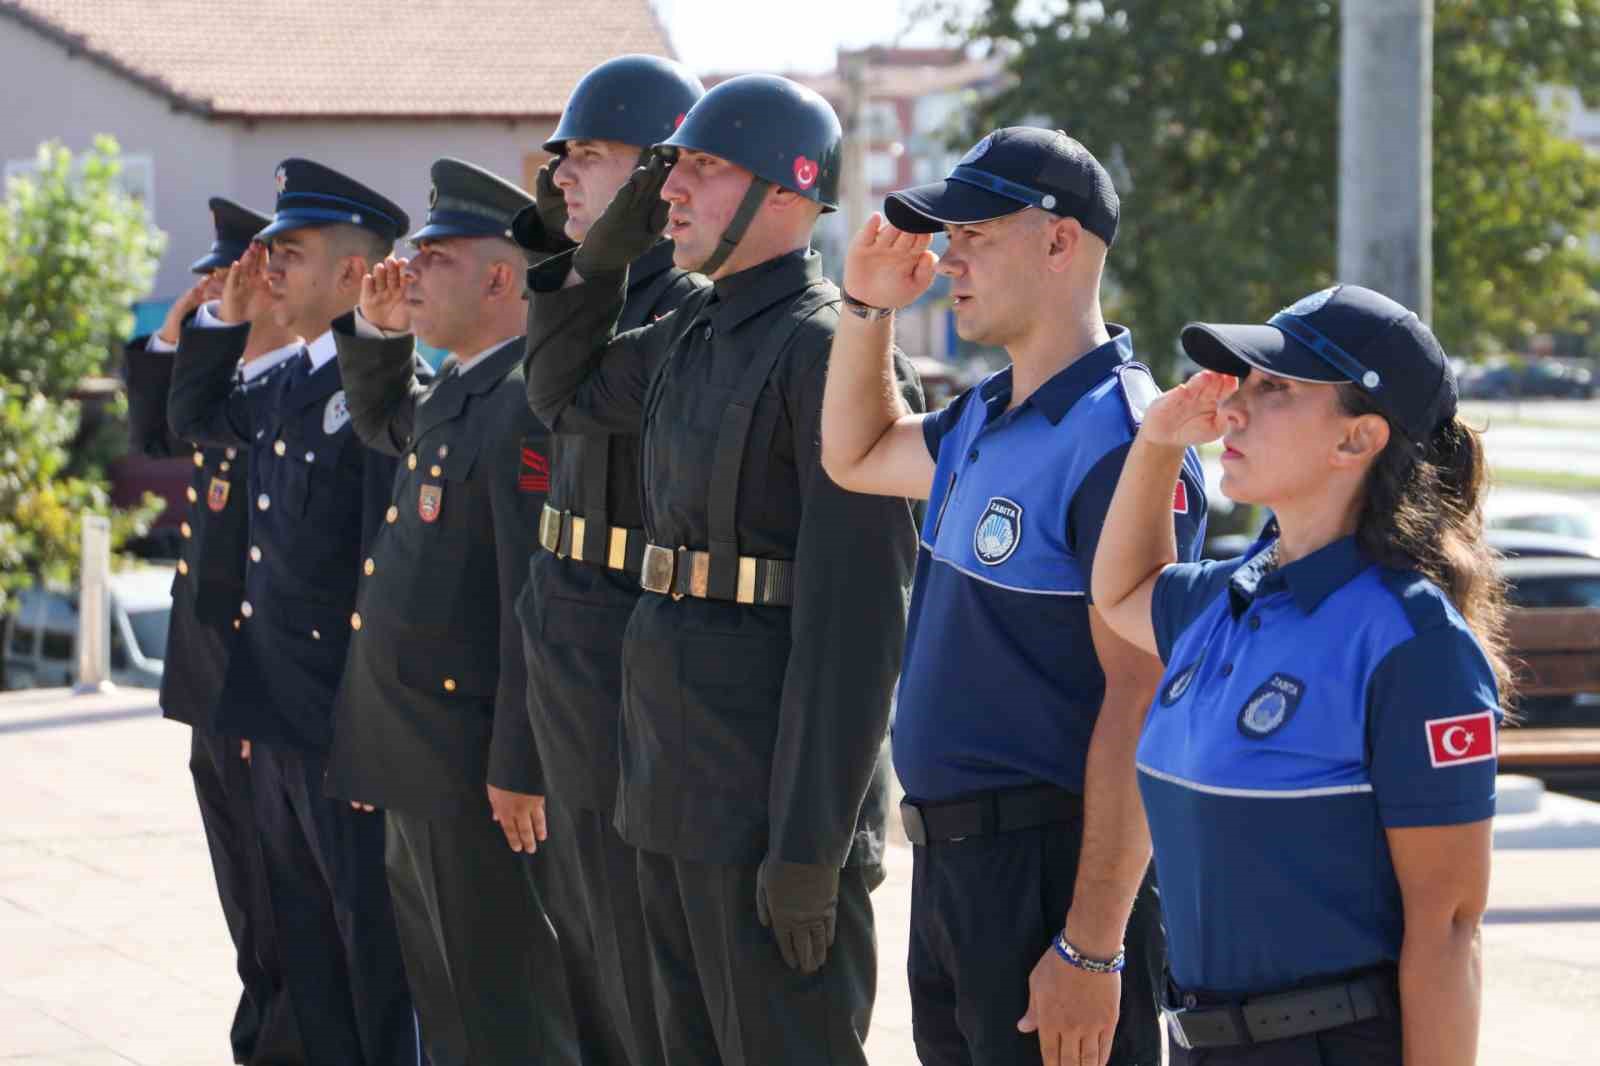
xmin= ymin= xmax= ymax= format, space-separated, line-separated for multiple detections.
xmin=328 ymin=315 xmax=549 ymax=818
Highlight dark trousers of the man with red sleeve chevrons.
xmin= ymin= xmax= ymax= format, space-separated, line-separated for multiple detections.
xmin=386 ymin=802 xmax=579 ymax=1066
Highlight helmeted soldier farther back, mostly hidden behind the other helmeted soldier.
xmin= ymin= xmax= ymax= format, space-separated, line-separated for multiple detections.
xmin=517 ymin=56 xmax=706 ymax=1066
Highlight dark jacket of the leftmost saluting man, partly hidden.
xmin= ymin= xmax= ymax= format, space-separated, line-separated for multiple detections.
xmin=123 ymin=336 xmax=250 ymax=730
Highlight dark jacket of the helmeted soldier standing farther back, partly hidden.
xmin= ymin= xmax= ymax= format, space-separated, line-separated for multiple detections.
xmin=518 ymin=242 xmax=707 ymax=816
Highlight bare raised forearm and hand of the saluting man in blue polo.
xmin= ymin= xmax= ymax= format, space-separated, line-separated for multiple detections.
xmin=822 ymin=213 xmax=938 ymax=499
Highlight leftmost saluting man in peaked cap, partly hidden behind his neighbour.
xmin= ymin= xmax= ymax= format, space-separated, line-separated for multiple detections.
xmin=123 ymin=197 xmax=301 ymax=1063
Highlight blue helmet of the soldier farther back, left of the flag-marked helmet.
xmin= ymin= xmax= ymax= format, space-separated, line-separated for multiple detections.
xmin=544 ymin=56 xmax=706 ymax=155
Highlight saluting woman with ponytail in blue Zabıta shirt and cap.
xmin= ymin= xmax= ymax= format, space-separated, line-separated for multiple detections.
xmin=1094 ymin=285 xmax=1509 ymax=1066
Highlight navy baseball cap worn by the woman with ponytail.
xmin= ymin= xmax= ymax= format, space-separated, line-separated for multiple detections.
xmin=1181 ymin=285 xmax=1456 ymax=445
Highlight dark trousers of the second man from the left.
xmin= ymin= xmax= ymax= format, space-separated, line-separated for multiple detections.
xmin=251 ymin=744 xmax=418 ymax=1066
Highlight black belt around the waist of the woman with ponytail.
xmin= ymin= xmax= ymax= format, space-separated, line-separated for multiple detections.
xmin=1162 ymin=968 xmax=1400 ymax=1048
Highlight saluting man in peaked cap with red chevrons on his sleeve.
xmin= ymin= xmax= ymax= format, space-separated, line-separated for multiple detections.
xmin=318 ymin=158 xmax=581 ymax=1066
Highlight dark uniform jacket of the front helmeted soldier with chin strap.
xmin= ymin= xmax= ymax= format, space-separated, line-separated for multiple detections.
xmin=528 ymin=251 xmax=922 ymax=866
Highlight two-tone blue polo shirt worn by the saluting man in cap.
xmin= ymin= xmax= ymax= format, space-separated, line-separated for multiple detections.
xmin=893 ymin=325 xmax=1205 ymax=802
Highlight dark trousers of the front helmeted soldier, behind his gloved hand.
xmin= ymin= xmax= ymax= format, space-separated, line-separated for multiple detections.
xmin=638 ymin=852 xmax=882 ymax=1066
